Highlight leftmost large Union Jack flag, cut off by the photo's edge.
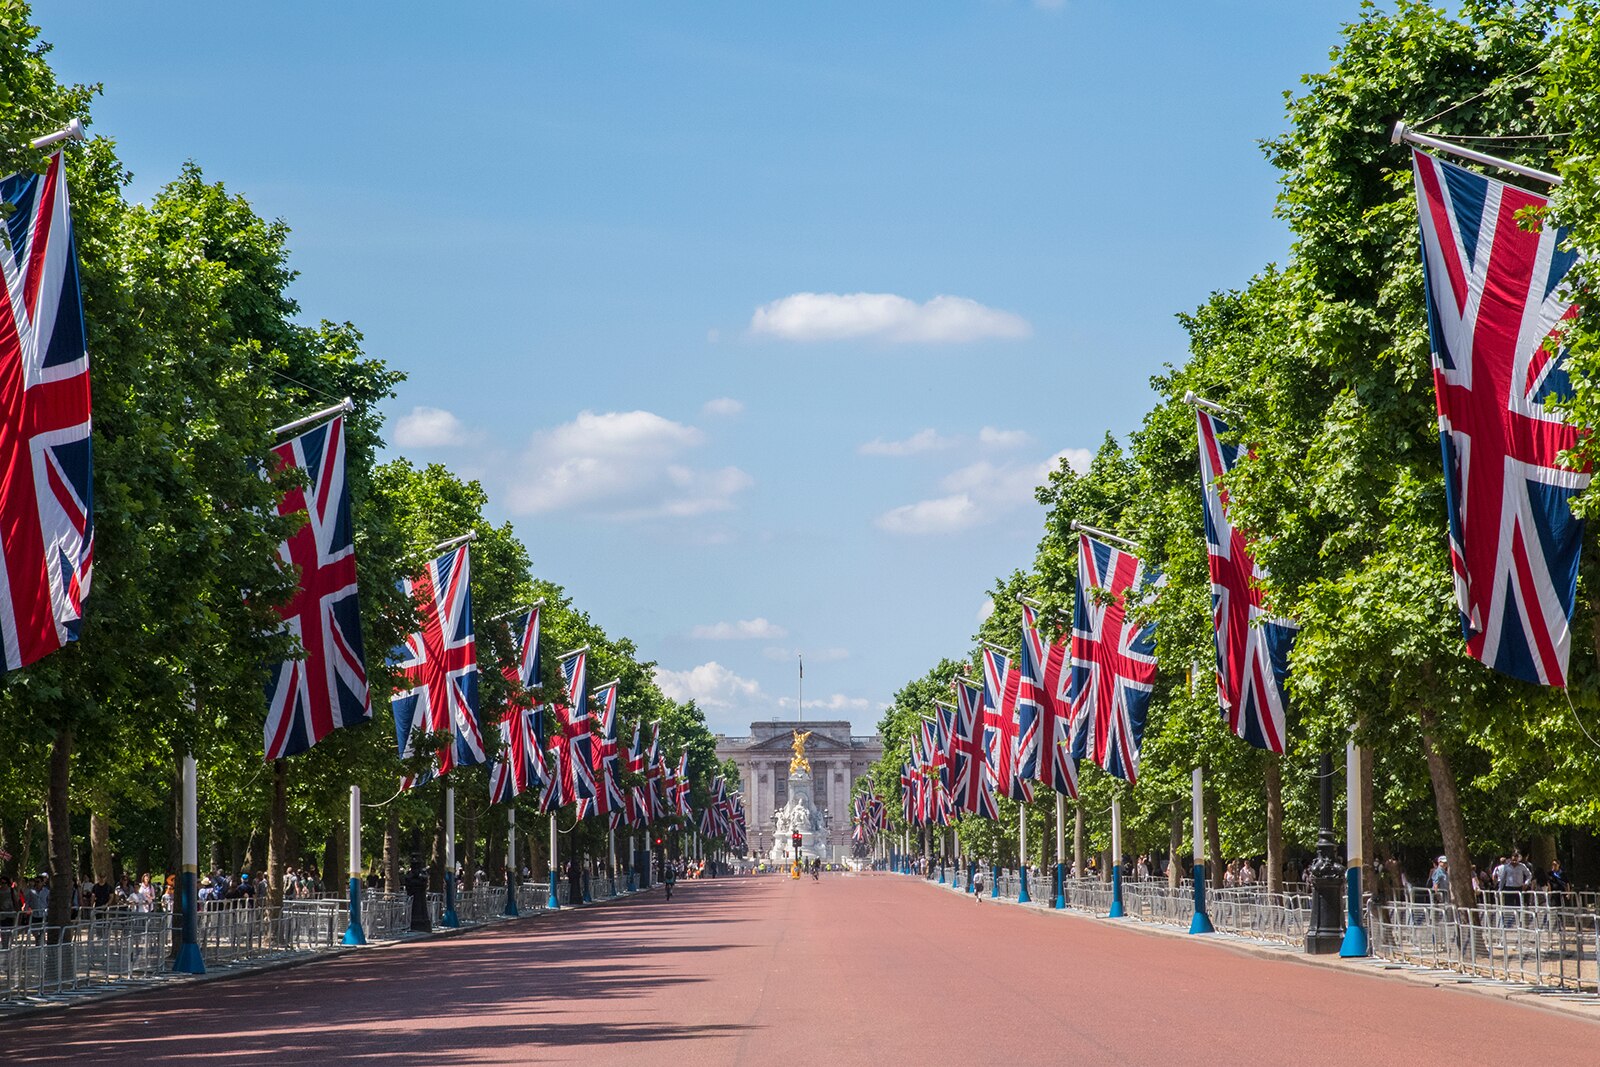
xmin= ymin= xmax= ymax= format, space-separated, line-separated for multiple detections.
xmin=0 ymin=152 xmax=94 ymax=670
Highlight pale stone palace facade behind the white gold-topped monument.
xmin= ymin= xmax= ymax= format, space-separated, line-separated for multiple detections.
xmin=717 ymin=720 xmax=883 ymax=857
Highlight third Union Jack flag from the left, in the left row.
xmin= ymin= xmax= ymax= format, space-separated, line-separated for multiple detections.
xmin=390 ymin=545 xmax=485 ymax=784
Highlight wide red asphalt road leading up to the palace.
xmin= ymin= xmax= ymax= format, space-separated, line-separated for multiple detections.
xmin=0 ymin=875 xmax=1600 ymax=1067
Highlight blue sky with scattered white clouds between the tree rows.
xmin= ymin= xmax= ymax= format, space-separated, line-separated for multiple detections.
xmin=35 ymin=0 xmax=1358 ymax=733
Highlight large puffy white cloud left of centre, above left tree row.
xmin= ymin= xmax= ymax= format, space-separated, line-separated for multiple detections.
xmin=510 ymin=411 xmax=754 ymax=518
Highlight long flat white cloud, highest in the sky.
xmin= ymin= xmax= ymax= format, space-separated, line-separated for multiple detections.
xmin=750 ymin=293 xmax=1034 ymax=344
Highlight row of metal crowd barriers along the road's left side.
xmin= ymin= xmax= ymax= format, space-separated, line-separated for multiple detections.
xmin=0 ymin=878 xmax=627 ymax=1005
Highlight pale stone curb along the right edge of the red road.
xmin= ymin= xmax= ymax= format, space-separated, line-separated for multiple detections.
xmin=918 ymin=878 xmax=1600 ymax=1022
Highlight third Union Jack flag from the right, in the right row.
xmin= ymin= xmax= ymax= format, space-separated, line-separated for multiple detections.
xmin=1067 ymin=533 xmax=1155 ymax=782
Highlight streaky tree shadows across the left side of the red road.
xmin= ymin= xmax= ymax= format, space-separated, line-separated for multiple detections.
xmin=0 ymin=881 xmax=764 ymax=1067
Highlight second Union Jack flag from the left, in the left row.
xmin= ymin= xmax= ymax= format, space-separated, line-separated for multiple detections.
xmin=262 ymin=416 xmax=373 ymax=760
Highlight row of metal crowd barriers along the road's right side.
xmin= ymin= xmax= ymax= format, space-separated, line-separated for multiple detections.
xmin=922 ymin=864 xmax=1600 ymax=993
